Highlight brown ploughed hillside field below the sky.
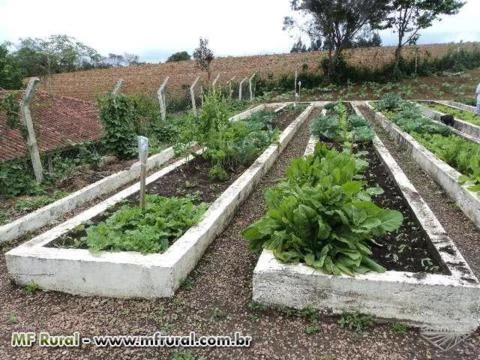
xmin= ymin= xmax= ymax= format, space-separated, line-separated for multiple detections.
xmin=41 ymin=43 xmax=478 ymax=101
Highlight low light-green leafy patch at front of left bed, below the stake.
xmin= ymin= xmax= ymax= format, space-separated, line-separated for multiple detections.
xmin=82 ymin=195 xmax=207 ymax=253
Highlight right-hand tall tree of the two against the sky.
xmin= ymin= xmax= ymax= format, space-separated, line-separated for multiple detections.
xmin=388 ymin=0 xmax=465 ymax=71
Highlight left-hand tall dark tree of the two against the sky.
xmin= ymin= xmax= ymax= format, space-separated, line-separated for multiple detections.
xmin=284 ymin=0 xmax=389 ymax=78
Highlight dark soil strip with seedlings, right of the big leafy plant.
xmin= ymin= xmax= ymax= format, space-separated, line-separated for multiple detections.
xmin=359 ymin=144 xmax=448 ymax=274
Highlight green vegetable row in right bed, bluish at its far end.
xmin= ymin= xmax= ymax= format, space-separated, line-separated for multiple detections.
xmin=375 ymin=94 xmax=480 ymax=192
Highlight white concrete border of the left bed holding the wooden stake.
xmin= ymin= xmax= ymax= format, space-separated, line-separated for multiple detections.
xmin=5 ymin=102 xmax=313 ymax=298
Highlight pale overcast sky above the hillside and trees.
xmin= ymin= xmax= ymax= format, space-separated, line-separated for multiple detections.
xmin=0 ymin=0 xmax=480 ymax=62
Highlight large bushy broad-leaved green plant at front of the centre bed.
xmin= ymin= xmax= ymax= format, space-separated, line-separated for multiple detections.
xmin=242 ymin=144 xmax=403 ymax=275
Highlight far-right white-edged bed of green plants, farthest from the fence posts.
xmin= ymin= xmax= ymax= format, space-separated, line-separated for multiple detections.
xmin=420 ymin=101 xmax=480 ymax=143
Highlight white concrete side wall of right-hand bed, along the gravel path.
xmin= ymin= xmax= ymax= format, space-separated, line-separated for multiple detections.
xmin=364 ymin=102 xmax=480 ymax=228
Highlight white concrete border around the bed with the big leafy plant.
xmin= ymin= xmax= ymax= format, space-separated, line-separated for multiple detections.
xmin=253 ymin=101 xmax=480 ymax=333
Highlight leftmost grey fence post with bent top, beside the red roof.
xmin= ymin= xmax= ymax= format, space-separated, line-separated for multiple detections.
xmin=20 ymin=78 xmax=43 ymax=184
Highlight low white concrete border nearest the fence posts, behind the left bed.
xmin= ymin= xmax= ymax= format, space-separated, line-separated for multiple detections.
xmin=0 ymin=104 xmax=268 ymax=244
